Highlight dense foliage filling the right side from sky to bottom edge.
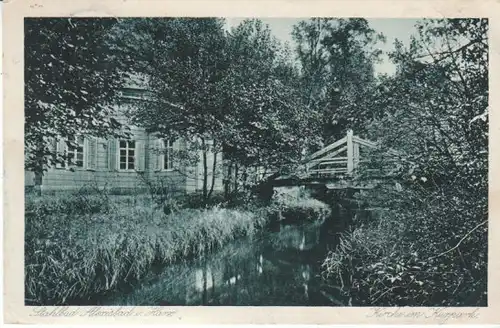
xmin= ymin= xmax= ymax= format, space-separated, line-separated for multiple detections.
xmin=325 ymin=19 xmax=488 ymax=306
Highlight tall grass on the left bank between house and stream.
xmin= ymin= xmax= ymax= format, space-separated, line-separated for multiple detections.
xmin=25 ymin=195 xmax=266 ymax=305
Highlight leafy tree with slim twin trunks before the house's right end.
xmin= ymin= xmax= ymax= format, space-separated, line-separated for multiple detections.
xmin=120 ymin=18 xmax=227 ymax=200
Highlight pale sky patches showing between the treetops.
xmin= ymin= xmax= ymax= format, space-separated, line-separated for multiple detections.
xmin=226 ymin=17 xmax=417 ymax=75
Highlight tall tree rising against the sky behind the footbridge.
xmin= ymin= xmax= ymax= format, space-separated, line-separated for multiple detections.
xmin=293 ymin=18 xmax=384 ymax=142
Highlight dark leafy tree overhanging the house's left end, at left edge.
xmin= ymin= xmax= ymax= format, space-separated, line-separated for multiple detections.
xmin=25 ymin=18 xmax=126 ymax=182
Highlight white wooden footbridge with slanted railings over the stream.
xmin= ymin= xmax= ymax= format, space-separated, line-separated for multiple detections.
xmin=272 ymin=130 xmax=397 ymax=189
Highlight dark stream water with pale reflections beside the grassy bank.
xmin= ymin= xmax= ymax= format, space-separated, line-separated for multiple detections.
xmin=103 ymin=218 xmax=348 ymax=306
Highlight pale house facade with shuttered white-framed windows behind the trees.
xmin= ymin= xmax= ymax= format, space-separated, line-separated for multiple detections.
xmin=25 ymin=77 xmax=223 ymax=193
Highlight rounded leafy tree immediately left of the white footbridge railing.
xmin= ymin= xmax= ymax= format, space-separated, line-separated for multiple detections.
xmin=224 ymin=19 xmax=314 ymax=190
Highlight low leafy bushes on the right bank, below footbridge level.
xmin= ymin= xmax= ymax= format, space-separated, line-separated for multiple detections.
xmin=323 ymin=187 xmax=487 ymax=306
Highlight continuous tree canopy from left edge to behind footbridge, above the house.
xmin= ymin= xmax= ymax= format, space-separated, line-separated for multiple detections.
xmin=26 ymin=18 xmax=381 ymax=198
